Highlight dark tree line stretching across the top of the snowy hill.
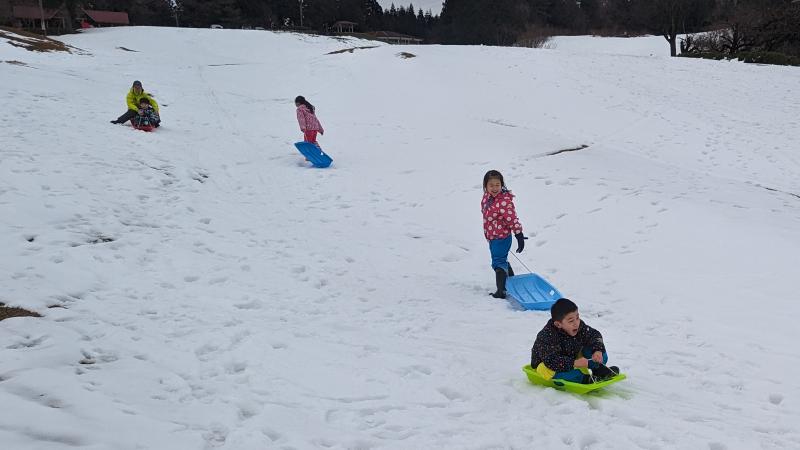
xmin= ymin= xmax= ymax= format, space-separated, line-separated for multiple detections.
xmin=69 ymin=0 xmax=800 ymax=56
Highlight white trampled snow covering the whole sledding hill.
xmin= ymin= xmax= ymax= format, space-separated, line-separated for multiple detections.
xmin=0 ymin=27 xmax=800 ymax=450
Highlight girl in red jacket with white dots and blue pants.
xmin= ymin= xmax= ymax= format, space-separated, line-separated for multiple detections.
xmin=481 ymin=170 xmax=528 ymax=298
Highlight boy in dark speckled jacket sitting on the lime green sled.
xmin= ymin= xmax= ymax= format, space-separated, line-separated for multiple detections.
xmin=531 ymin=298 xmax=619 ymax=384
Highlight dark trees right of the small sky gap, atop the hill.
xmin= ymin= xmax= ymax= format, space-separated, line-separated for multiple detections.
xmin=435 ymin=0 xmax=800 ymax=56
